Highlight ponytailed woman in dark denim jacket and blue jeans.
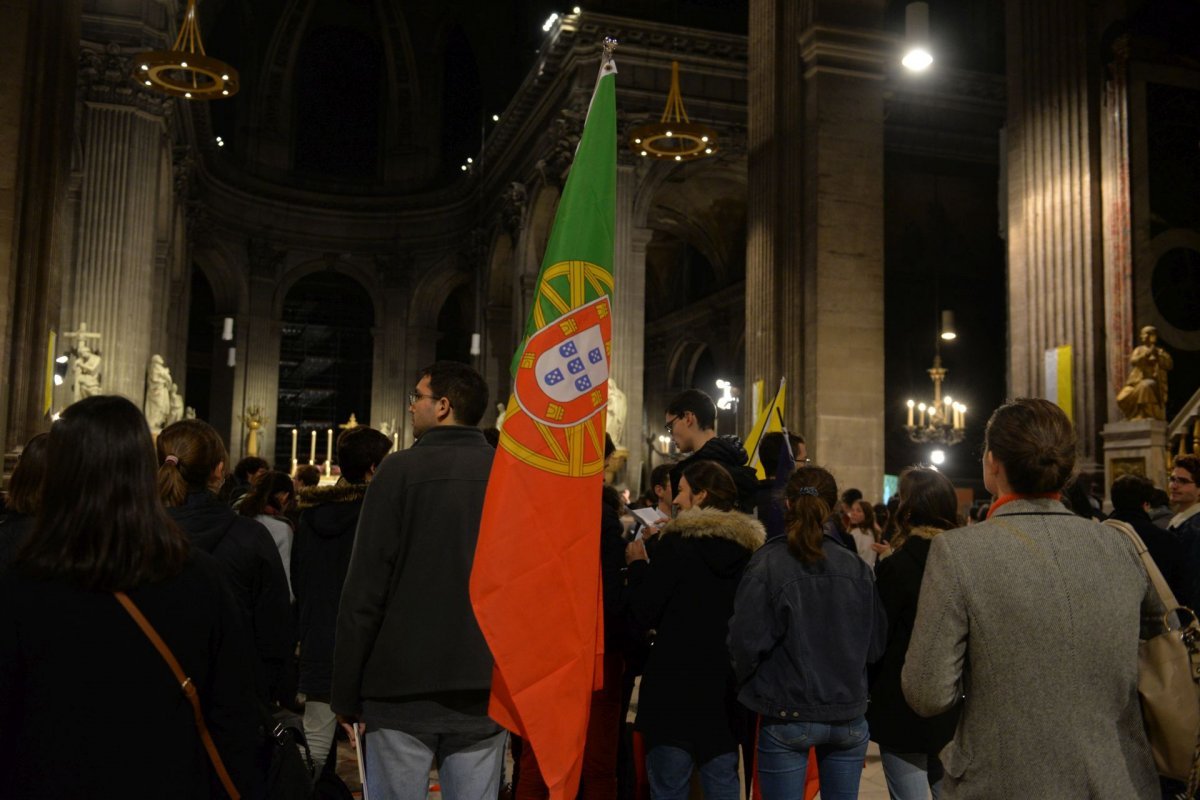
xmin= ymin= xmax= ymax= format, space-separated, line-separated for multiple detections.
xmin=728 ymin=467 xmax=887 ymax=800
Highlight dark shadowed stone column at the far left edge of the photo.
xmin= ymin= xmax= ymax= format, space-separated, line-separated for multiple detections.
xmin=0 ymin=0 xmax=82 ymax=453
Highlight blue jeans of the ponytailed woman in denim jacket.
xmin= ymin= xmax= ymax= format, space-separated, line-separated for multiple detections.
xmin=758 ymin=717 xmax=871 ymax=800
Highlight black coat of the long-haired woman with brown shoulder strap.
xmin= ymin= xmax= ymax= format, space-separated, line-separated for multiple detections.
xmin=0 ymin=551 xmax=262 ymax=799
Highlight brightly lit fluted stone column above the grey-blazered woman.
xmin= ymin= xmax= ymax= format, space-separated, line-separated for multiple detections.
xmin=1006 ymin=0 xmax=1105 ymax=462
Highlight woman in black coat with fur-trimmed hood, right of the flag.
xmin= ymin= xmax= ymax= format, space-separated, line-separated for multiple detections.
xmin=625 ymin=461 xmax=767 ymax=800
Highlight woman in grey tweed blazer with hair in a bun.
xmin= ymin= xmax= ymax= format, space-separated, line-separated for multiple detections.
xmin=901 ymin=399 xmax=1159 ymax=800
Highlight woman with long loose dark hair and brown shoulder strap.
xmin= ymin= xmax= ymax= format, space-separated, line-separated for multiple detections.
xmin=0 ymin=396 xmax=259 ymax=798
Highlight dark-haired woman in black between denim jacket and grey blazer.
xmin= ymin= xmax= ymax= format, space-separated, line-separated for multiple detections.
xmin=866 ymin=467 xmax=959 ymax=800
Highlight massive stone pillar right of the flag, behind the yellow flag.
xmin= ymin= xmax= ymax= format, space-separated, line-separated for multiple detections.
xmin=745 ymin=0 xmax=892 ymax=497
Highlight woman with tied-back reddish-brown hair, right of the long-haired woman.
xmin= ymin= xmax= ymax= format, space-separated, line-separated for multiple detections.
xmin=156 ymin=420 xmax=295 ymax=702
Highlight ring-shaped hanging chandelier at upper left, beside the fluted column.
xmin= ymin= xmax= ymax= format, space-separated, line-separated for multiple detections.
xmin=133 ymin=0 xmax=238 ymax=100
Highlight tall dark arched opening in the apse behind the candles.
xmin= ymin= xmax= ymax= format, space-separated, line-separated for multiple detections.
xmin=275 ymin=271 xmax=374 ymax=465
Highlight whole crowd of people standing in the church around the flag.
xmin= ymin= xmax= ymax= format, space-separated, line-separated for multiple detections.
xmin=0 ymin=362 xmax=1200 ymax=800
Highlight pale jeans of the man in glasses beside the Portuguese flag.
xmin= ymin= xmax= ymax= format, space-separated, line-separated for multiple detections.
xmin=364 ymin=728 xmax=509 ymax=800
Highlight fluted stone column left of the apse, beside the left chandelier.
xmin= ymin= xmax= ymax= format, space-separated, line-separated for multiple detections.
xmin=67 ymin=46 xmax=169 ymax=399
